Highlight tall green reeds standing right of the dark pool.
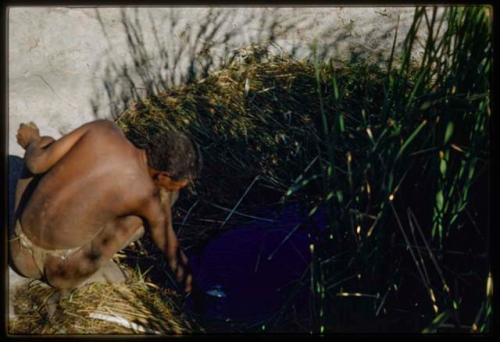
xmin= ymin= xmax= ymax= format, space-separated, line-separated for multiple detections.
xmin=310 ymin=6 xmax=492 ymax=333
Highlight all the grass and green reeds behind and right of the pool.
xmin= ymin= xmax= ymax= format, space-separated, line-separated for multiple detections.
xmin=116 ymin=6 xmax=492 ymax=333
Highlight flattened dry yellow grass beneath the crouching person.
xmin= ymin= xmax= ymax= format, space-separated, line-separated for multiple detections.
xmin=9 ymin=269 xmax=197 ymax=335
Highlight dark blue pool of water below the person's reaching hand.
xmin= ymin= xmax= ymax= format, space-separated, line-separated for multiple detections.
xmin=186 ymin=205 xmax=325 ymax=332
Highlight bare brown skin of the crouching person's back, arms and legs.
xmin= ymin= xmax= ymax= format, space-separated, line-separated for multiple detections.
xmin=10 ymin=120 xmax=192 ymax=292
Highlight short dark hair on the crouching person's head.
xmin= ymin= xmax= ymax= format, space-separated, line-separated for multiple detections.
xmin=145 ymin=131 xmax=202 ymax=181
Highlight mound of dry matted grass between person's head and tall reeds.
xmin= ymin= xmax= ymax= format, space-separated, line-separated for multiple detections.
xmin=116 ymin=46 xmax=384 ymax=246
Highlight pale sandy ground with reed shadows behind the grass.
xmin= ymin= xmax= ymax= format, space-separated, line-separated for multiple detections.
xmin=8 ymin=6 xmax=430 ymax=326
